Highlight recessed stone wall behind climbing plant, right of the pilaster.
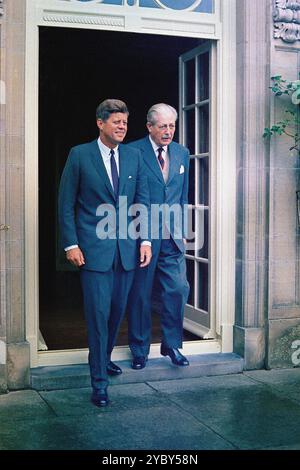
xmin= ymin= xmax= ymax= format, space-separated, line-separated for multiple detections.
xmin=268 ymin=0 xmax=300 ymax=368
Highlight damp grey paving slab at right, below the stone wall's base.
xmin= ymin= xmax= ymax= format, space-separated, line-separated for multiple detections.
xmin=151 ymin=376 xmax=300 ymax=449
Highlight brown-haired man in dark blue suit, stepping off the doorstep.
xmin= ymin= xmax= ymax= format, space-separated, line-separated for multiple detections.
xmin=59 ymin=99 xmax=151 ymax=406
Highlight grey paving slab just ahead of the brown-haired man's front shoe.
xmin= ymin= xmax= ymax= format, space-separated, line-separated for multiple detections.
xmin=54 ymin=406 xmax=233 ymax=450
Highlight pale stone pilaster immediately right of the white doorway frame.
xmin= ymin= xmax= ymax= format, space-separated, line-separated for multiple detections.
xmin=234 ymin=0 xmax=272 ymax=369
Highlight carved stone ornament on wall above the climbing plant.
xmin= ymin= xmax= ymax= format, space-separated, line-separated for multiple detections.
xmin=273 ymin=0 xmax=300 ymax=43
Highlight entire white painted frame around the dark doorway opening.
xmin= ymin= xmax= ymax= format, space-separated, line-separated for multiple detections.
xmin=25 ymin=0 xmax=236 ymax=367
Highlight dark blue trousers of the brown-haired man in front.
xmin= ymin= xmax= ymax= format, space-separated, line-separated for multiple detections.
xmin=80 ymin=250 xmax=134 ymax=391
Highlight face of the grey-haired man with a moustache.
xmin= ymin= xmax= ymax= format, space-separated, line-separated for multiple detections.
xmin=147 ymin=113 xmax=176 ymax=146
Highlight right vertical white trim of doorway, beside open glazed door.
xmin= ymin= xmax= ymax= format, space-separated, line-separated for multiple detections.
xmin=215 ymin=0 xmax=236 ymax=353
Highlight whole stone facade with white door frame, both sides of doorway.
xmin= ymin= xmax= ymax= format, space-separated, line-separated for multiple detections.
xmin=0 ymin=0 xmax=300 ymax=391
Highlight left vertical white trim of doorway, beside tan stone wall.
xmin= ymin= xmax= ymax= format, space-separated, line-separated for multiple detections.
xmin=25 ymin=1 xmax=39 ymax=367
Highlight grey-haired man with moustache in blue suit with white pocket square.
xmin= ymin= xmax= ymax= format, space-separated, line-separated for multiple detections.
xmin=128 ymin=103 xmax=189 ymax=369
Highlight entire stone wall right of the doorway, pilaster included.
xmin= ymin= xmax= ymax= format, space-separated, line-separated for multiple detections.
xmin=234 ymin=0 xmax=300 ymax=369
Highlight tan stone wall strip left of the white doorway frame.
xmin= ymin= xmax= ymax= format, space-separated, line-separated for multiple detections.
xmin=0 ymin=0 xmax=29 ymax=389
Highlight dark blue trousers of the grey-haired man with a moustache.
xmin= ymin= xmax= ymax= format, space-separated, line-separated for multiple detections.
xmin=128 ymin=238 xmax=189 ymax=356
